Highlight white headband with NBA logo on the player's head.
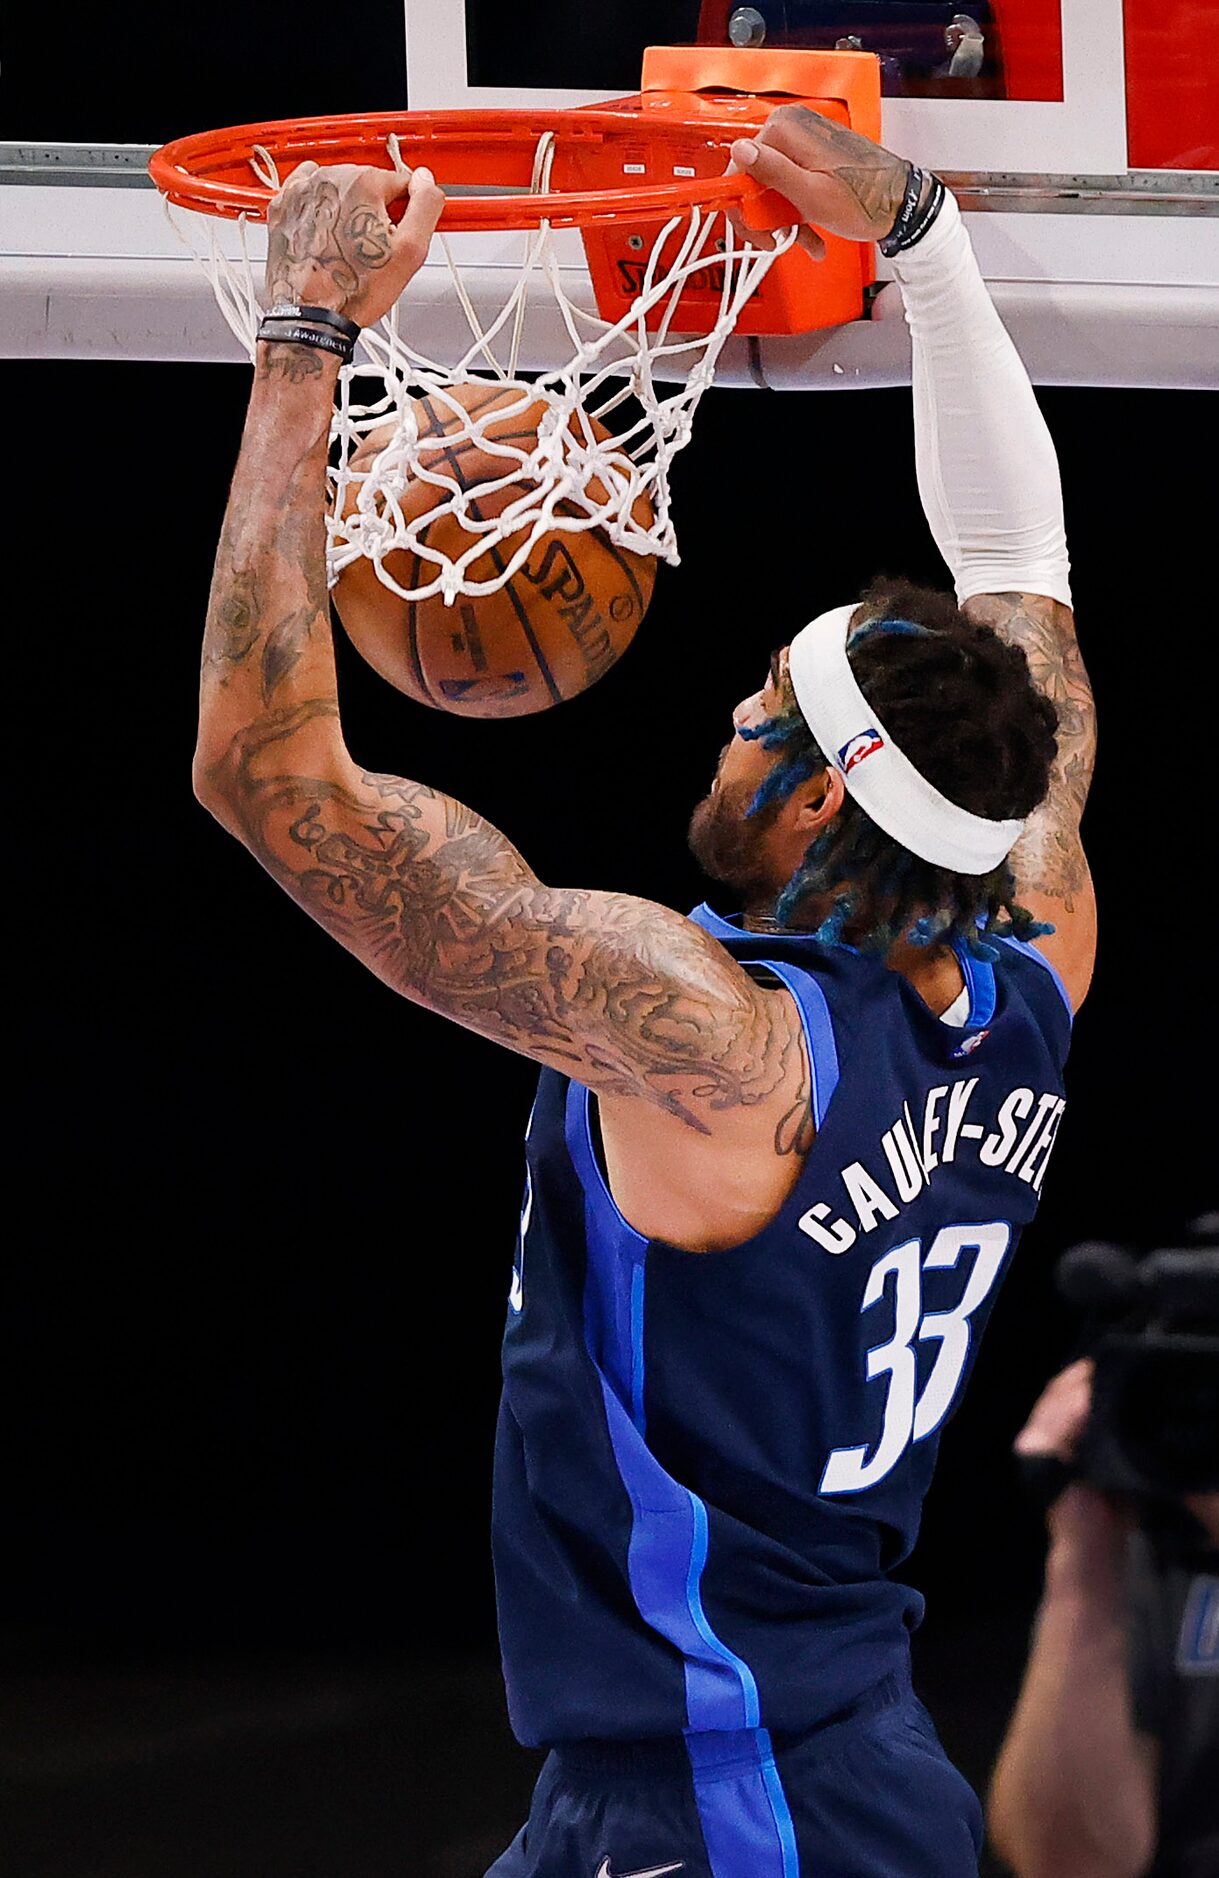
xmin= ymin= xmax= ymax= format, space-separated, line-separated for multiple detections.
xmin=787 ymin=603 xmax=1024 ymax=873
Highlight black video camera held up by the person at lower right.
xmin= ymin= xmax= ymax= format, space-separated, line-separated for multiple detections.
xmin=1056 ymin=1215 xmax=1219 ymax=1499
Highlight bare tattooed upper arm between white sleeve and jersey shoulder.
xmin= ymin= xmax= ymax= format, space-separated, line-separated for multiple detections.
xmin=962 ymin=593 xmax=1097 ymax=1010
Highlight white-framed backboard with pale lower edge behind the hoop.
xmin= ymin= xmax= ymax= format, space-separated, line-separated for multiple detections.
xmin=0 ymin=0 xmax=1219 ymax=389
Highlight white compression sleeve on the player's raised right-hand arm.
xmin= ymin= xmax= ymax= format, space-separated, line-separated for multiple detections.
xmin=894 ymin=193 xmax=1071 ymax=607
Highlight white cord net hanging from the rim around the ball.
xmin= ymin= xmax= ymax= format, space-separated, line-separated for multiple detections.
xmin=175 ymin=131 xmax=796 ymax=601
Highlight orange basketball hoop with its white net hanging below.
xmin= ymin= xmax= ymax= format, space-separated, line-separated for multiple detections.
xmin=148 ymin=53 xmax=875 ymax=603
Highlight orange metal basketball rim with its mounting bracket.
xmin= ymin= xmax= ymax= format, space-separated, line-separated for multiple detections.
xmin=148 ymin=45 xmax=881 ymax=334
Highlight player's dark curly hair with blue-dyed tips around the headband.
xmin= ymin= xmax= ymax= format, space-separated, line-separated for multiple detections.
xmin=746 ymin=578 xmax=1057 ymax=958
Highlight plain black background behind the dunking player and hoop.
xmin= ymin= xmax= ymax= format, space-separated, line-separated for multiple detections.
xmin=0 ymin=0 xmax=1215 ymax=1878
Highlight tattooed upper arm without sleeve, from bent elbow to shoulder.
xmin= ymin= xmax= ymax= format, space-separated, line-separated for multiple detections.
xmin=197 ymin=706 xmax=802 ymax=1134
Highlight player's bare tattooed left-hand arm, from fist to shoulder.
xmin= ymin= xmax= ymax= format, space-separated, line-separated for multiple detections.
xmin=195 ymin=165 xmax=802 ymax=1136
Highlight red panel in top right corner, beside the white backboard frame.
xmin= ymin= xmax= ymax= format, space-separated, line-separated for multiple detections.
xmin=1125 ymin=0 xmax=1219 ymax=169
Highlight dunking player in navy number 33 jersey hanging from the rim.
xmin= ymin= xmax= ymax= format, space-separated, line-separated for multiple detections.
xmin=195 ymin=107 xmax=1095 ymax=1878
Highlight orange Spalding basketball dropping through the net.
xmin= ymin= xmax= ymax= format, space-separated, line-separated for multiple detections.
xmin=334 ymin=383 xmax=656 ymax=717
